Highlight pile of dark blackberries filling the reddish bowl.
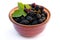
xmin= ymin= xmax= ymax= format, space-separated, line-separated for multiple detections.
xmin=13 ymin=3 xmax=47 ymax=25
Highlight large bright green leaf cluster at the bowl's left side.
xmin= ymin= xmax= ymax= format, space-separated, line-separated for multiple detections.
xmin=13 ymin=3 xmax=27 ymax=17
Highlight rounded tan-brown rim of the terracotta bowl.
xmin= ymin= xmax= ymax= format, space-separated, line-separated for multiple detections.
xmin=8 ymin=6 xmax=51 ymax=27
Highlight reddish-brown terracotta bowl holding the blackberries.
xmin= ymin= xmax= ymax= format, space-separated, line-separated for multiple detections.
xmin=9 ymin=7 xmax=50 ymax=37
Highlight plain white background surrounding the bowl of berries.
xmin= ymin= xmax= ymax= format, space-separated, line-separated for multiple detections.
xmin=0 ymin=0 xmax=60 ymax=40
